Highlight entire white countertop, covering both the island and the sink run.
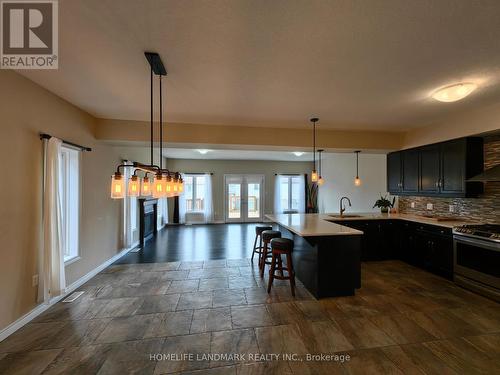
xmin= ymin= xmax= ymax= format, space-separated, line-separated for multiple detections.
xmin=266 ymin=213 xmax=471 ymax=237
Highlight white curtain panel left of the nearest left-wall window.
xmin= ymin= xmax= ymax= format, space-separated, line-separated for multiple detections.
xmin=37 ymin=137 xmax=66 ymax=303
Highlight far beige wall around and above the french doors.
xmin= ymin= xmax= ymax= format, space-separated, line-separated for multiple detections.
xmin=167 ymin=159 xmax=312 ymax=221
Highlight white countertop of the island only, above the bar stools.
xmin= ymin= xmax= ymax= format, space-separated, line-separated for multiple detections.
xmin=266 ymin=214 xmax=363 ymax=237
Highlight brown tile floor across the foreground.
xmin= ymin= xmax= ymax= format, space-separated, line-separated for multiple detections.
xmin=0 ymin=259 xmax=500 ymax=375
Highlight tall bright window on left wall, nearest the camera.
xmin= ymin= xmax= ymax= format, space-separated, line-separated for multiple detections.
xmin=59 ymin=146 xmax=80 ymax=262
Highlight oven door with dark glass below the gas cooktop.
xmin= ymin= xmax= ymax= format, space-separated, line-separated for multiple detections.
xmin=453 ymin=235 xmax=500 ymax=291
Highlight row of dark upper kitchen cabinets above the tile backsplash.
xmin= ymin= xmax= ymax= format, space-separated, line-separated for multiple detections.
xmin=387 ymin=137 xmax=483 ymax=197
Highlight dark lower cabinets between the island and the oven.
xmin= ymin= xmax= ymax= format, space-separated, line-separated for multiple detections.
xmin=337 ymin=220 xmax=453 ymax=279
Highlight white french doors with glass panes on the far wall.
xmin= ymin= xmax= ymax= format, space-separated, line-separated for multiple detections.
xmin=224 ymin=174 xmax=264 ymax=223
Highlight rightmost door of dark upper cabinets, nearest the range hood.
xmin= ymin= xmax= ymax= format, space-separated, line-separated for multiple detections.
xmin=440 ymin=139 xmax=466 ymax=194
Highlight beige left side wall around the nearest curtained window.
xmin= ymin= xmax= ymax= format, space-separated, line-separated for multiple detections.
xmin=0 ymin=70 xmax=156 ymax=329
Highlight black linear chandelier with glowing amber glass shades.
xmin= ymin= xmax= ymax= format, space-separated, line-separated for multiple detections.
xmin=111 ymin=52 xmax=184 ymax=199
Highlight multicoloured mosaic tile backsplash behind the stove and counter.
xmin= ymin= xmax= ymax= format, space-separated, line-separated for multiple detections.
xmin=399 ymin=135 xmax=500 ymax=223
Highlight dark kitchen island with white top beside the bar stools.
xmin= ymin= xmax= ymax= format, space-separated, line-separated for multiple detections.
xmin=266 ymin=214 xmax=363 ymax=298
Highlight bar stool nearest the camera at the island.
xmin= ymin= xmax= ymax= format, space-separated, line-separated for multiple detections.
xmin=267 ymin=238 xmax=295 ymax=297
